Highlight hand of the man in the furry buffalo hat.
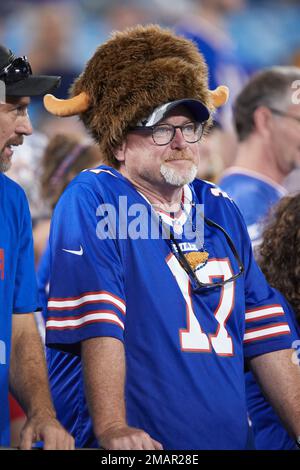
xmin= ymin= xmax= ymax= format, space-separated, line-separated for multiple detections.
xmin=99 ymin=426 xmax=163 ymax=450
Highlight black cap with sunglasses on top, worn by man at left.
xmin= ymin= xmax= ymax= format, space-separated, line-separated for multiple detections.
xmin=0 ymin=45 xmax=61 ymax=96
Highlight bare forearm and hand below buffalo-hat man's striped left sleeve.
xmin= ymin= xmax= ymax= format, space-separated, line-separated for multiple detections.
xmin=81 ymin=337 xmax=163 ymax=450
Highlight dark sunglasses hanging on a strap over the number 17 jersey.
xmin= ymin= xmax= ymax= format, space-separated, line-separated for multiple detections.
xmin=170 ymin=217 xmax=245 ymax=293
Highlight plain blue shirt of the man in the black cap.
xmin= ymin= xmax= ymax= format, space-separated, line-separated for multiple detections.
xmin=0 ymin=173 xmax=38 ymax=446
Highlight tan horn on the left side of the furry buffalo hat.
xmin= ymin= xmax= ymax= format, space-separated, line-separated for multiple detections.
xmin=44 ymin=91 xmax=90 ymax=117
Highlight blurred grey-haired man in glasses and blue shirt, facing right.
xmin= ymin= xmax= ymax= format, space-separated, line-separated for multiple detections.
xmin=218 ymin=66 xmax=300 ymax=247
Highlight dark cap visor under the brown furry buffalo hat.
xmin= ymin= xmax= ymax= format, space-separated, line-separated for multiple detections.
xmin=137 ymin=98 xmax=210 ymax=127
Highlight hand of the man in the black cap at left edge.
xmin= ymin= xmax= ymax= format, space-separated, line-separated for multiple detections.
xmin=20 ymin=416 xmax=75 ymax=450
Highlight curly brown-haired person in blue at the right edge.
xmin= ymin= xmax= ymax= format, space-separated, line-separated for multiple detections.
xmin=246 ymin=193 xmax=300 ymax=450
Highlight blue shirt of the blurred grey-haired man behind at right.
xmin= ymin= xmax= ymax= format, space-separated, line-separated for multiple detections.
xmin=219 ymin=167 xmax=287 ymax=246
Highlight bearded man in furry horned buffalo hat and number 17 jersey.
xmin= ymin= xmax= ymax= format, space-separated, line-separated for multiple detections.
xmin=44 ymin=25 xmax=300 ymax=449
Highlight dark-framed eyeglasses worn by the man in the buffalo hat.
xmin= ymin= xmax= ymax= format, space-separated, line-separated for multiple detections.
xmin=130 ymin=122 xmax=205 ymax=145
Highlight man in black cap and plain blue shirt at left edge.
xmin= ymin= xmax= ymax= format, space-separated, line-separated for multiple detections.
xmin=0 ymin=46 xmax=74 ymax=449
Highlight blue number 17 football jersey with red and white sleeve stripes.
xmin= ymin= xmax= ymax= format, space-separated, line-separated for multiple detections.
xmin=47 ymin=166 xmax=293 ymax=449
